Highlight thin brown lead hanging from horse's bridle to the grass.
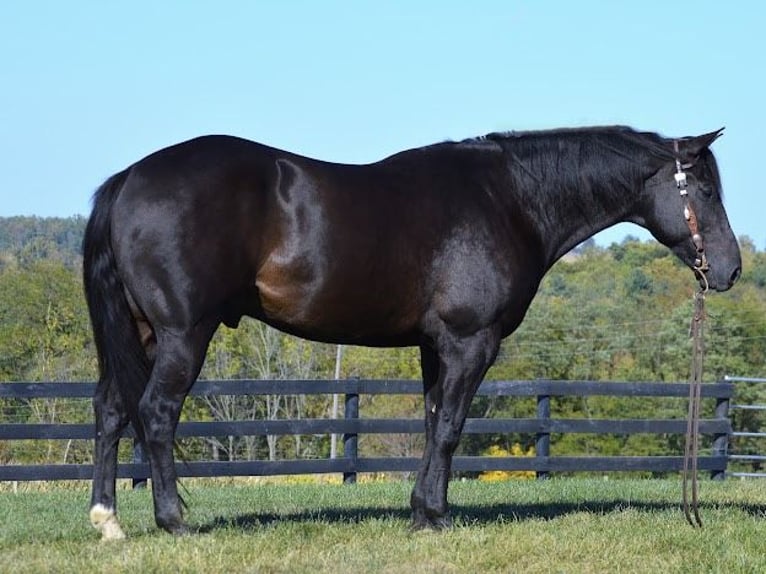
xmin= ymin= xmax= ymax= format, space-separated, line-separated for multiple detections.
xmin=683 ymin=290 xmax=707 ymax=528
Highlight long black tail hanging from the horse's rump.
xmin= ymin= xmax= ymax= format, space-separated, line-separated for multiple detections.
xmin=83 ymin=170 xmax=151 ymax=440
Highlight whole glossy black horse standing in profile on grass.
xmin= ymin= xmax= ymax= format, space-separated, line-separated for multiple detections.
xmin=84 ymin=127 xmax=741 ymax=538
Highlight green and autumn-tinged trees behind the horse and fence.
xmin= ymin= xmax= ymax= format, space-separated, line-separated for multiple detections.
xmin=0 ymin=217 xmax=766 ymax=474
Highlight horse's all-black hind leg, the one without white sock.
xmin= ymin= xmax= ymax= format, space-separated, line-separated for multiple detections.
xmin=139 ymin=323 xmax=217 ymax=534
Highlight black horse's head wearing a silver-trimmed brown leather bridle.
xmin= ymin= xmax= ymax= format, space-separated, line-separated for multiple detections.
xmin=637 ymin=130 xmax=742 ymax=291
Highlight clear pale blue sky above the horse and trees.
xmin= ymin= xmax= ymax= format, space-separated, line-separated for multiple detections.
xmin=0 ymin=0 xmax=766 ymax=248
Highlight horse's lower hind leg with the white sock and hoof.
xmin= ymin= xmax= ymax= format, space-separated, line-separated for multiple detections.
xmin=90 ymin=378 xmax=128 ymax=540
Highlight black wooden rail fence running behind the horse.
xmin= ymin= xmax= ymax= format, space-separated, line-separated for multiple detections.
xmin=0 ymin=380 xmax=734 ymax=482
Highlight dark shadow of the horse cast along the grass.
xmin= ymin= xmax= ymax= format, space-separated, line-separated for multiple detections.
xmin=198 ymin=500 xmax=766 ymax=534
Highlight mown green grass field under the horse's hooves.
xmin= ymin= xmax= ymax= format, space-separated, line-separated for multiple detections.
xmin=0 ymin=479 xmax=766 ymax=574
